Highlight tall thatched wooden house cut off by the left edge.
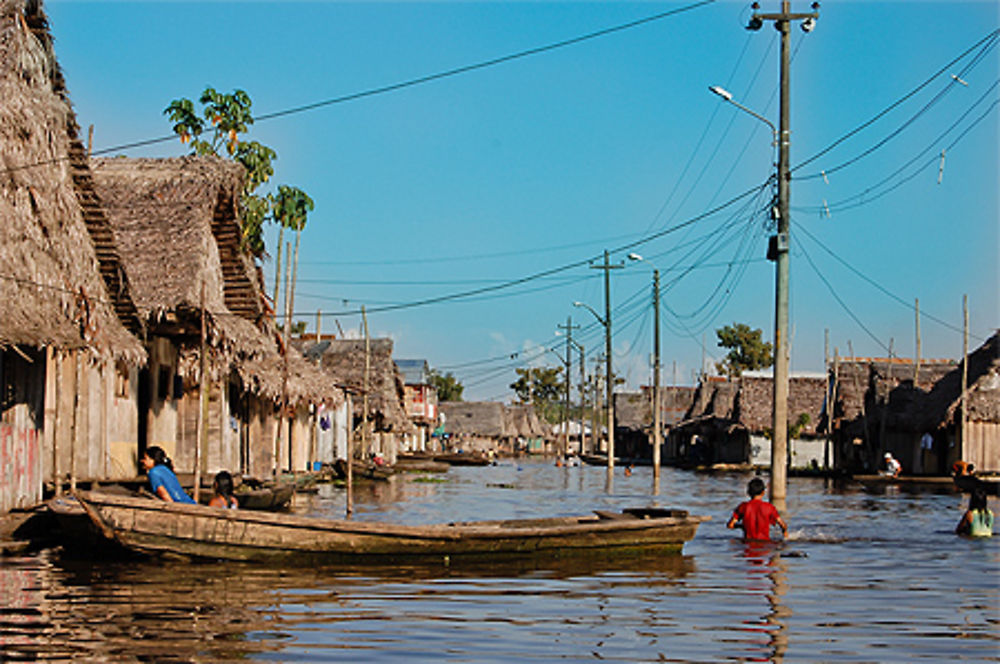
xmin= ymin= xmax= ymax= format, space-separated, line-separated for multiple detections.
xmin=0 ymin=0 xmax=145 ymax=512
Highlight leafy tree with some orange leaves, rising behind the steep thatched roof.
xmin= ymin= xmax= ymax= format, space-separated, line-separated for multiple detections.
xmin=163 ymin=86 xmax=278 ymax=257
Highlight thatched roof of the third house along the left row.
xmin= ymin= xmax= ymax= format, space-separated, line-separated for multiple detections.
xmin=304 ymin=339 xmax=414 ymax=432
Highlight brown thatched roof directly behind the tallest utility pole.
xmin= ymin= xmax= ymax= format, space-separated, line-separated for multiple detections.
xmin=735 ymin=374 xmax=827 ymax=436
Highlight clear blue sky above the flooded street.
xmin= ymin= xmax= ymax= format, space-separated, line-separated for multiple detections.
xmin=46 ymin=0 xmax=1000 ymax=400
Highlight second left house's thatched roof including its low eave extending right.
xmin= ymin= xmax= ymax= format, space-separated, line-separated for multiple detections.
xmin=93 ymin=157 xmax=343 ymax=403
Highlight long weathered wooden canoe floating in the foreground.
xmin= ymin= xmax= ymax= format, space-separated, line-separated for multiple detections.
xmin=70 ymin=491 xmax=710 ymax=563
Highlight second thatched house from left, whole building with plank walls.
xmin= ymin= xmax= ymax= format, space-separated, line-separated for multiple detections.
xmin=93 ymin=157 xmax=342 ymax=475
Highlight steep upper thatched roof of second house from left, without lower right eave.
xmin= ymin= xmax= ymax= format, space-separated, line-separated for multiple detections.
xmin=92 ymin=157 xmax=273 ymax=365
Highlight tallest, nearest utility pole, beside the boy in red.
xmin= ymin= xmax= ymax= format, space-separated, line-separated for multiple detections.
xmin=747 ymin=0 xmax=819 ymax=509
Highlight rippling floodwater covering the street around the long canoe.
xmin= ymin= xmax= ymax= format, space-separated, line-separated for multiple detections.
xmin=0 ymin=461 xmax=1000 ymax=662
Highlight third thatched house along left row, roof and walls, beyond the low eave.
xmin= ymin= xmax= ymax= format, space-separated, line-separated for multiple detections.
xmin=298 ymin=335 xmax=415 ymax=463
